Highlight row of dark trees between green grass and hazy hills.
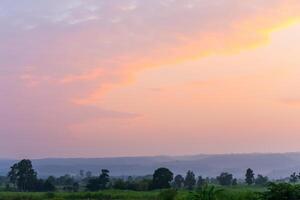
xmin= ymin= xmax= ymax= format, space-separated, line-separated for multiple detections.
xmin=0 ymin=159 xmax=300 ymax=192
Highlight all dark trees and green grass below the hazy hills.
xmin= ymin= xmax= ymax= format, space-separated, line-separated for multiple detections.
xmin=0 ymin=160 xmax=300 ymax=200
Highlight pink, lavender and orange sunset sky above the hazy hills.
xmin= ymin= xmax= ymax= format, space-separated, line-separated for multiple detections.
xmin=0 ymin=0 xmax=300 ymax=158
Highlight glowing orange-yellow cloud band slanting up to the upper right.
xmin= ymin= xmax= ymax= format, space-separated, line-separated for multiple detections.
xmin=74 ymin=0 xmax=300 ymax=104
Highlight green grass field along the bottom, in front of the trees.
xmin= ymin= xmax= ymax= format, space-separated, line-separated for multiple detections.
xmin=0 ymin=186 xmax=264 ymax=200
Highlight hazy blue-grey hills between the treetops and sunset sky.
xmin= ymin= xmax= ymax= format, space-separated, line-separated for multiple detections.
xmin=0 ymin=153 xmax=300 ymax=178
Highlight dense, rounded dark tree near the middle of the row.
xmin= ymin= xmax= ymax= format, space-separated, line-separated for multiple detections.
xmin=152 ymin=168 xmax=173 ymax=189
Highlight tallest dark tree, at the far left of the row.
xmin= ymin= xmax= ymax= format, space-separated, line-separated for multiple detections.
xmin=7 ymin=159 xmax=37 ymax=191
